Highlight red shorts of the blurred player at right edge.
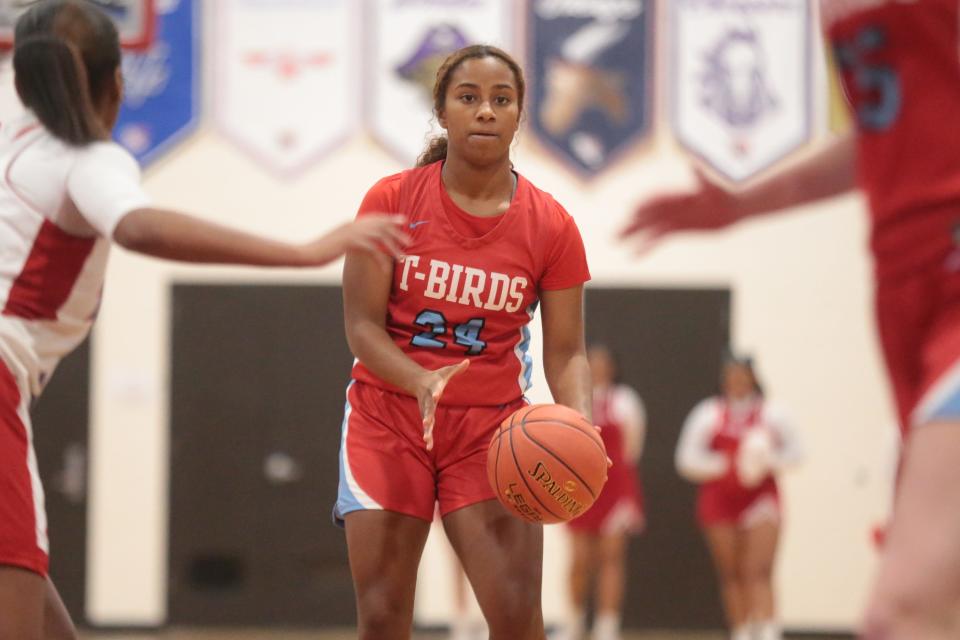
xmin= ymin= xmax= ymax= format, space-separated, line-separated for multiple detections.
xmin=876 ymin=255 xmax=960 ymax=433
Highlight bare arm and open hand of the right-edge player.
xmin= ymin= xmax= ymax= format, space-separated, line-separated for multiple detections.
xmin=621 ymin=134 xmax=856 ymax=247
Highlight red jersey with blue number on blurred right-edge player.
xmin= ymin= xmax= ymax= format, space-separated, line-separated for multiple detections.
xmin=821 ymin=0 xmax=960 ymax=275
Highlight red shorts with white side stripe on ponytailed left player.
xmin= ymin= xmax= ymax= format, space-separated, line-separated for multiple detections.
xmin=0 ymin=361 xmax=49 ymax=576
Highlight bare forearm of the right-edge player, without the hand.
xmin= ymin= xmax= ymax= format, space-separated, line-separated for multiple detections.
xmin=734 ymin=136 xmax=856 ymax=219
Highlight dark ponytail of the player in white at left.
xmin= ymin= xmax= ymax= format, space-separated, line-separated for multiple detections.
xmin=13 ymin=35 xmax=109 ymax=146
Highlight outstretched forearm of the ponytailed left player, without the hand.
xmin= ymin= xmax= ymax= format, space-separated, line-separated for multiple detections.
xmin=113 ymin=209 xmax=320 ymax=267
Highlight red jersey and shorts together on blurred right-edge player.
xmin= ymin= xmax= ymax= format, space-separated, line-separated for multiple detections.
xmin=821 ymin=0 xmax=960 ymax=429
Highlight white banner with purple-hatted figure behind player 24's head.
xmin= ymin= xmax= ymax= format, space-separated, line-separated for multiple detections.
xmin=365 ymin=0 xmax=513 ymax=165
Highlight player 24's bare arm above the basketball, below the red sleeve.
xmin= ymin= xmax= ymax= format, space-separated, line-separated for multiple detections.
xmin=540 ymin=284 xmax=592 ymax=420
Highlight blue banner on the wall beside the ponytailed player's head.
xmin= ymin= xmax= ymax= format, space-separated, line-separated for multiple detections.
xmin=114 ymin=0 xmax=200 ymax=165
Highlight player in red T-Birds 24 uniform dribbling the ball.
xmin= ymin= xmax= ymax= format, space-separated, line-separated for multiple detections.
xmin=336 ymin=46 xmax=590 ymax=640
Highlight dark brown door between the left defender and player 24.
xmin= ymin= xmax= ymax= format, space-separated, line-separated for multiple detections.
xmin=170 ymin=285 xmax=355 ymax=625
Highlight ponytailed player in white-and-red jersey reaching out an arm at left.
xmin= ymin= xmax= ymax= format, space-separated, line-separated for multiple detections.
xmin=0 ymin=0 xmax=406 ymax=640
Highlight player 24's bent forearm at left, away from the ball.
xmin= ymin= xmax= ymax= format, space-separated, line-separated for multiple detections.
xmin=347 ymin=320 xmax=429 ymax=395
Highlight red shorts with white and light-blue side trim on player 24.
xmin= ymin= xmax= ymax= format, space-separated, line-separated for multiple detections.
xmin=334 ymin=382 xmax=526 ymax=522
